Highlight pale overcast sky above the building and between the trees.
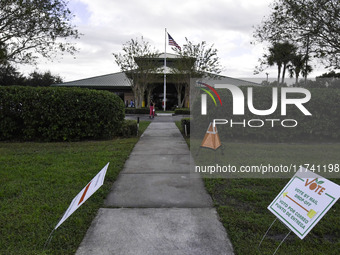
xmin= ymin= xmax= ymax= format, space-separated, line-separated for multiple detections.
xmin=20 ymin=0 xmax=325 ymax=81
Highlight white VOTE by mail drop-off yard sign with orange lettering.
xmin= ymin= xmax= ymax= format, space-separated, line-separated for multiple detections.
xmin=268 ymin=167 xmax=340 ymax=239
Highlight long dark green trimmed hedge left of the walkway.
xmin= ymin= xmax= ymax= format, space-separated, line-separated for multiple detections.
xmin=0 ymin=86 xmax=124 ymax=141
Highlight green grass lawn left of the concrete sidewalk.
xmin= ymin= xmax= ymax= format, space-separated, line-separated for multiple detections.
xmin=0 ymin=122 xmax=150 ymax=255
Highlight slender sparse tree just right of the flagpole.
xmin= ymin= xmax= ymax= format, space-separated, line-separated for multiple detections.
xmin=172 ymin=38 xmax=222 ymax=107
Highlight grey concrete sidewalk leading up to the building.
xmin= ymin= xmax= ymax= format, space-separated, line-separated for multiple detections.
xmin=76 ymin=122 xmax=233 ymax=255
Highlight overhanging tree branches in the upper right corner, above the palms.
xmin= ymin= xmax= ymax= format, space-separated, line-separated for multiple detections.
xmin=254 ymin=0 xmax=340 ymax=68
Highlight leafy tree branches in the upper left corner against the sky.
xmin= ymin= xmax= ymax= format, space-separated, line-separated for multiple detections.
xmin=0 ymin=0 xmax=79 ymax=64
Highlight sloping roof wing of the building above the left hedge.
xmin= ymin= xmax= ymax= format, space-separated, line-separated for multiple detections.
xmin=53 ymin=72 xmax=131 ymax=89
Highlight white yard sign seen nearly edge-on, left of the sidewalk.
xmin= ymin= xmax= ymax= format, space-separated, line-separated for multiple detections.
xmin=54 ymin=163 xmax=110 ymax=229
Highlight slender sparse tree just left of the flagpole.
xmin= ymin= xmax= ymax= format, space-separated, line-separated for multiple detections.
xmin=113 ymin=37 xmax=159 ymax=107
